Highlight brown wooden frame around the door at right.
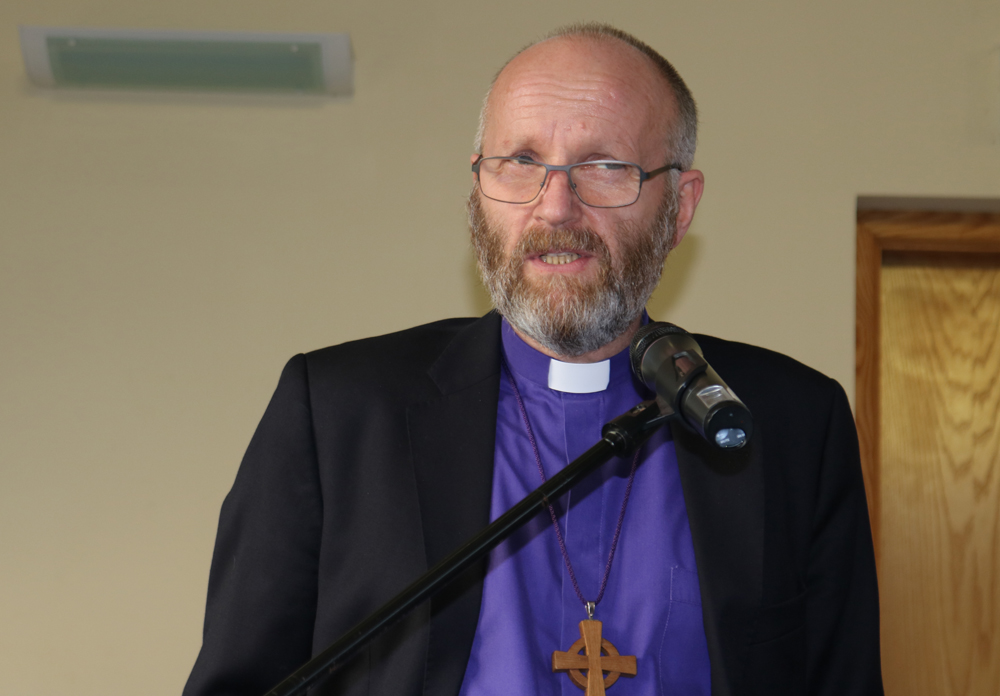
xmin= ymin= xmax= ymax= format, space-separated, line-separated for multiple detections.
xmin=854 ymin=199 xmax=1000 ymax=559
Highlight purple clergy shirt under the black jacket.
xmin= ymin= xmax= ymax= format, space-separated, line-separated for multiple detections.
xmin=460 ymin=321 xmax=711 ymax=696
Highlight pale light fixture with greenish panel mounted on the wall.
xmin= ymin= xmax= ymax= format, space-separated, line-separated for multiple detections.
xmin=19 ymin=27 xmax=354 ymax=96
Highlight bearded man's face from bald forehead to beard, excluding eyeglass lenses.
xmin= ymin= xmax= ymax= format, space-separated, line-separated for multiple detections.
xmin=470 ymin=39 xmax=677 ymax=356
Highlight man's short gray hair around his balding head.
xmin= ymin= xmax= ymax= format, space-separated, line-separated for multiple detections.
xmin=473 ymin=22 xmax=698 ymax=169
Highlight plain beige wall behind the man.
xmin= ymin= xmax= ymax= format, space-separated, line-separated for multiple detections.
xmin=0 ymin=0 xmax=1000 ymax=696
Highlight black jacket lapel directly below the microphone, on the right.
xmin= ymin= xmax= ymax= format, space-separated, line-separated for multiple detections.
xmin=672 ymin=421 xmax=764 ymax=696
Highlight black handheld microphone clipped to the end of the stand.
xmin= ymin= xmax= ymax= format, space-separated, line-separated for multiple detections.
xmin=629 ymin=321 xmax=753 ymax=449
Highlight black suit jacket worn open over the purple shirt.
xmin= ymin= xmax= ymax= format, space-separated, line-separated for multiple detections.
xmin=184 ymin=313 xmax=881 ymax=696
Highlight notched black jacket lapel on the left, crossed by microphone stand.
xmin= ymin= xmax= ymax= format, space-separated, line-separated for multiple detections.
xmin=407 ymin=312 xmax=500 ymax=696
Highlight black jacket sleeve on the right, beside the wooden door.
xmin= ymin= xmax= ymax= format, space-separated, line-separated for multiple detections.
xmin=805 ymin=385 xmax=882 ymax=696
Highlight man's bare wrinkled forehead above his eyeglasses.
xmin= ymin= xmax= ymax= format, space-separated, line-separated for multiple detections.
xmin=484 ymin=38 xmax=674 ymax=159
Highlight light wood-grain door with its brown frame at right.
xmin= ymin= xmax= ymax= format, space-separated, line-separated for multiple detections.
xmin=856 ymin=211 xmax=1000 ymax=696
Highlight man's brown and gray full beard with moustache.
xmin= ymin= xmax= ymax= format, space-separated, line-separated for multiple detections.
xmin=468 ymin=187 xmax=677 ymax=357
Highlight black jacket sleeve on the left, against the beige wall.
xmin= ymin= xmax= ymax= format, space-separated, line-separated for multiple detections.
xmin=184 ymin=355 xmax=323 ymax=696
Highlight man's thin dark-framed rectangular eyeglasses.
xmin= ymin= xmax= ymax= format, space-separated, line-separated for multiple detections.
xmin=472 ymin=155 xmax=681 ymax=208
